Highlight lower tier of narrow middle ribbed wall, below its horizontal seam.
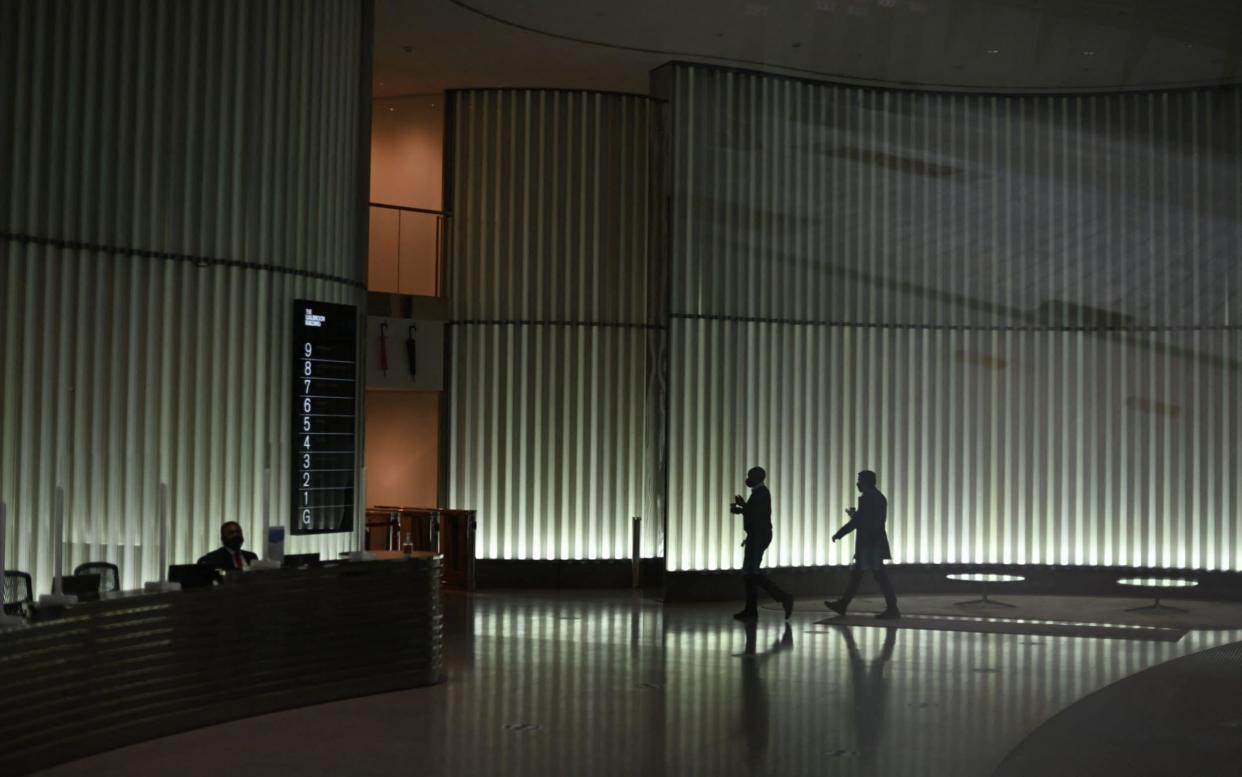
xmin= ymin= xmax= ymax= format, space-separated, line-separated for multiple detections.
xmin=450 ymin=325 xmax=660 ymax=559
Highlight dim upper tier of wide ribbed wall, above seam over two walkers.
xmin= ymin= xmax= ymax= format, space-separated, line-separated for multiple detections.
xmin=657 ymin=66 xmax=1242 ymax=326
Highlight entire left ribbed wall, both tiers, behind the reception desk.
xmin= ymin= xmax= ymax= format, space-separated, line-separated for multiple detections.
xmin=0 ymin=0 xmax=365 ymax=592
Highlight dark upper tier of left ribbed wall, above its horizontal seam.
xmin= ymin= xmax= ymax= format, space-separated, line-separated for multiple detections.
xmin=0 ymin=0 xmax=368 ymax=279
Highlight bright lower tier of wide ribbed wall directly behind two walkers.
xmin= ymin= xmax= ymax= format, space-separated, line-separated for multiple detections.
xmin=668 ymin=320 xmax=1242 ymax=570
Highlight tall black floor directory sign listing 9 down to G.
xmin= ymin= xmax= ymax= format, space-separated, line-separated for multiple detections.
xmin=291 ymin=299 xmax=358 ymax=534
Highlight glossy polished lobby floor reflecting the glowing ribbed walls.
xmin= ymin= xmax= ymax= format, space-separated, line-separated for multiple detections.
xmin=29 ymin=591 xmax=1242 ymax=777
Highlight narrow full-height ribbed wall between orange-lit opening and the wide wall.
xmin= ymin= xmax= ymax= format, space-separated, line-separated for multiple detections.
xmin=448 ymin=89 xmax=662 ymax=559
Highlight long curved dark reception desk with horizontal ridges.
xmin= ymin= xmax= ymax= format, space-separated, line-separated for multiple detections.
xmin=0 ymin=555 xmax=442 ymax=776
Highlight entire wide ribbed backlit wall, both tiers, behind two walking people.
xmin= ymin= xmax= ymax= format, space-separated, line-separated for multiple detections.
xmin=667 ymin=67 xmax=1242 ymax=570
